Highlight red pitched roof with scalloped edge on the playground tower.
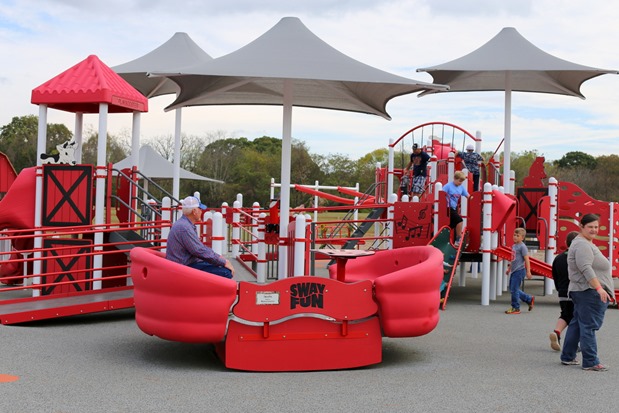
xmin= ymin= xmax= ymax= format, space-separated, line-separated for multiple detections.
xmin=30 ymin=55 xmax=148 ymax=113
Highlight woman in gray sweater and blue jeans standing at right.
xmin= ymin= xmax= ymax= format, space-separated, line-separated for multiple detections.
xmin=561 ymin=214 xmax=614 ymax=371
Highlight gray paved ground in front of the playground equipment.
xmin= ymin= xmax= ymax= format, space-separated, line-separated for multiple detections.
xmin=0 ymin=264 xmax=619 ymax=413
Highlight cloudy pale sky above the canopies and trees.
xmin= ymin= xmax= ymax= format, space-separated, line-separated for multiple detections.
xmin=0 ymin=0 xmax=619 ymax=159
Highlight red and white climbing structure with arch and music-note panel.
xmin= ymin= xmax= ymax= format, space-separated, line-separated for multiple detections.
xmin=389 ymin=122 xmax=619 ymax=305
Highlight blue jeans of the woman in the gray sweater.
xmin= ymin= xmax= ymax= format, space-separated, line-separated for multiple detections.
xmin=561 ymin=288 xmax=608 ymax=368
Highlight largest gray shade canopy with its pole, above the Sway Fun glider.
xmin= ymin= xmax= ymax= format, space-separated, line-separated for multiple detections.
xmin=153 ymin=17 xmax=447 ymax=277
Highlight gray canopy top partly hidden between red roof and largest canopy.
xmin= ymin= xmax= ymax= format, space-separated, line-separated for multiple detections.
xmin=112 ymin=32 xmax=213 ymax=98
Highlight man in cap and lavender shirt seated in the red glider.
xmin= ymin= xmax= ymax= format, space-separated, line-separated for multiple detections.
xmin=166 ymin=196 xmax=234 ymax=278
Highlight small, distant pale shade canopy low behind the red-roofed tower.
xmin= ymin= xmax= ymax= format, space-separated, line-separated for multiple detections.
xmin=114 ymin=145 xmax=224 ymax=184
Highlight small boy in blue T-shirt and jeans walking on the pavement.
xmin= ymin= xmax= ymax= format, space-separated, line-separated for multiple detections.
xmin=505 ymin=228 xmax=535 ymax=314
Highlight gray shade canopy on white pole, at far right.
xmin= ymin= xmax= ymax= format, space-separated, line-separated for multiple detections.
xmin=417 ymin=27 xmax=618 ymax=193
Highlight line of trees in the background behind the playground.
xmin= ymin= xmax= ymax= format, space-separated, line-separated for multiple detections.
xmin=0 ymin=115 xmax=619 ymax=206
